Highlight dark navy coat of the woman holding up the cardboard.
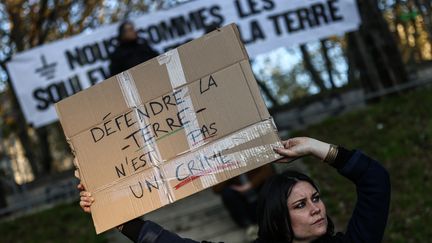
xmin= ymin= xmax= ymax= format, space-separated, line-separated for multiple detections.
xmin=122 ymin=151 xmax=390 ymax=243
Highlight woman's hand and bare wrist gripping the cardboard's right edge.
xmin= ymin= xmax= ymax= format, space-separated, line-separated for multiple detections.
xmin=274 ymin=137 xmax=330 ymax=162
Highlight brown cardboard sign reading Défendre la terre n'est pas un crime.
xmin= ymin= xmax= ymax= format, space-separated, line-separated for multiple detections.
xmin=56 ymin=25 xmax=280 ymax=233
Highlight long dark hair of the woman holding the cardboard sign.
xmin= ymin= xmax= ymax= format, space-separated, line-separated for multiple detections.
xmin=257 ymin=171 xmax=334 ymax=242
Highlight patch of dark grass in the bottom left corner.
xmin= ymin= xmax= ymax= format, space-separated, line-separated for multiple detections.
xmin=0 ymin=202 xmax=107 ymax=243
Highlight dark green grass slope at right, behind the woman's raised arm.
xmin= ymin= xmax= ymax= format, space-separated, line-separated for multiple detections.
xmin=293 ymin=88 xmax=432 ymax=242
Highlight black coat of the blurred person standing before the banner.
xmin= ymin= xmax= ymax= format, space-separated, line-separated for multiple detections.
xmin=110 ymin=40 xmax=159 ymax=76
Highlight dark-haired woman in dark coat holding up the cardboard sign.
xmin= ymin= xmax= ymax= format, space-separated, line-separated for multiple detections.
xmin=78 ymin=137 xmax=390 ymax=243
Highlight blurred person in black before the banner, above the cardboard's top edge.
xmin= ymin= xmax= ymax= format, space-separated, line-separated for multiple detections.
xmin=109 ymin=21 xmax=159 ymax=76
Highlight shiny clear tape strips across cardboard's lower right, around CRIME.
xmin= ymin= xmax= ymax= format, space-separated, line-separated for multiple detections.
xmin=164 ymin=119 xmax=282 ymax=190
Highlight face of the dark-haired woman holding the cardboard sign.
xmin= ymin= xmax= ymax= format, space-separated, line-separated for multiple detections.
xmin=287 ymin=181 xmax=328 ymax=240
